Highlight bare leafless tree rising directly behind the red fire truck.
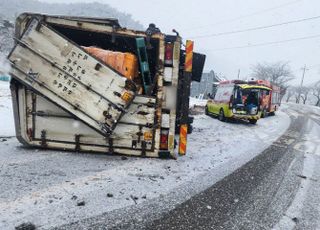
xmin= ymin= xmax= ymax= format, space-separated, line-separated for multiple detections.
xmin=252 ymin=62 xmax=295 ymax=99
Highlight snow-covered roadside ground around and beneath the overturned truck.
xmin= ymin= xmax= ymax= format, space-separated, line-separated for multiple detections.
xmin=0 ymin=87 xmax=290 ymax=229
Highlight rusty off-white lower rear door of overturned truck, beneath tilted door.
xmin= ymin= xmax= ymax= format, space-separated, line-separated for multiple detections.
xmin=18 ymin=87 xmax=155 ymax=156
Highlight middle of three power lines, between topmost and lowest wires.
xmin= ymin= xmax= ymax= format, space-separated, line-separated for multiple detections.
xmin=191 ymin=15 xmax=320 ymax=39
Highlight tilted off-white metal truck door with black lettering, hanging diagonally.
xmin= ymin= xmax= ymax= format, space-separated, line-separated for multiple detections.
xmin=9 ymin=19 xmax=134 ymax=135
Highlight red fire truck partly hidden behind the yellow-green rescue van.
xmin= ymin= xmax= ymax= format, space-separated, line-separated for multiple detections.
xmin=249 ymin=80 xmax=281 ymax=118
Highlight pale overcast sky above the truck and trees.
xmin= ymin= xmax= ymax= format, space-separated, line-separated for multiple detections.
xmin=42 ymin=0 xmax=320 ymax=84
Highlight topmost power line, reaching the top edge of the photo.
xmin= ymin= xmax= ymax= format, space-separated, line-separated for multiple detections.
xmin=184 ymin=0 xmax=303 ymax=32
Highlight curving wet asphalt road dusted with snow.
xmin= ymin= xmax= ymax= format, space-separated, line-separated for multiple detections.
xmin=58 ymin=108 xmax=320 ymax=230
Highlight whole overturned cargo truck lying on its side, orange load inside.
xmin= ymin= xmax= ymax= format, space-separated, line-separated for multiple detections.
xmin=8 ymin=13 xmax=205 ymax=158
